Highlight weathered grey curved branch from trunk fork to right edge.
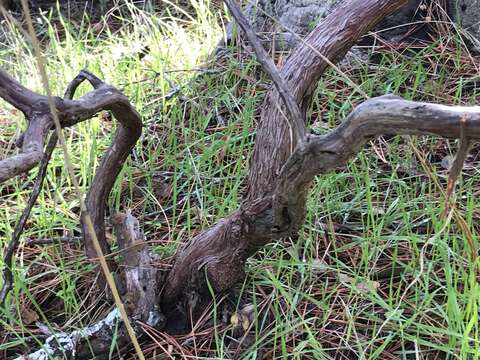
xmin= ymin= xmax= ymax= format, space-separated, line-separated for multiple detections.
xmin=273 ymin=95 xmax=480 ymax=228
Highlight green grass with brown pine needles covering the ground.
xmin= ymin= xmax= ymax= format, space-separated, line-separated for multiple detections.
xmin=0 ymin=0 xmax=480 ymax=360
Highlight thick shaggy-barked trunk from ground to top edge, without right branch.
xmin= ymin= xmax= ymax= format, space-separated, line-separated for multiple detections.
xmin=162 ymin=0 xmax=406 ymax=324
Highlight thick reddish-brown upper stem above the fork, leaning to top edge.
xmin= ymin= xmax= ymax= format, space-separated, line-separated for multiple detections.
xmin=244 ymin=0 xmax=407 ymax=203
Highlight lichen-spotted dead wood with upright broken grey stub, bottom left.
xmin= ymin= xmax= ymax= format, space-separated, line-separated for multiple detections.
xmin=16 ymin=212 xmax=165 ymax=360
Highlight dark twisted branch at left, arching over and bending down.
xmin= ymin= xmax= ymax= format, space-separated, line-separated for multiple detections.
xmin=0 ymin=70 xmax=142 ymax=268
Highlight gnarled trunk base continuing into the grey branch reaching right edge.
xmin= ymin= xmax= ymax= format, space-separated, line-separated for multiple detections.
xmin=163 ymin=95 xmax=480 ymax=321
